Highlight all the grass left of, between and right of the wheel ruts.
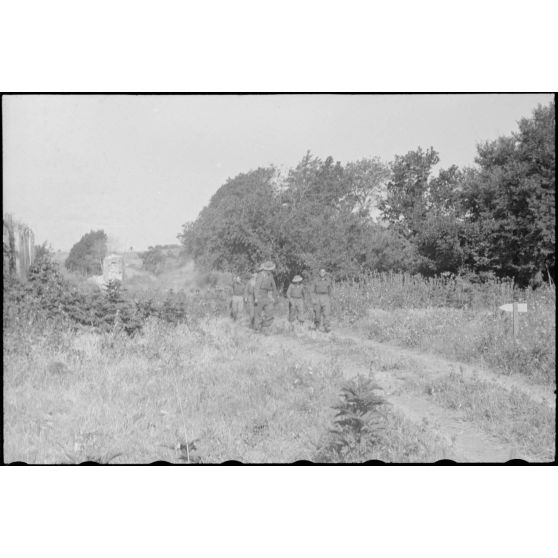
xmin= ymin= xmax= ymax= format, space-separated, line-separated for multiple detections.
xmin=3 ymin=269 xmax=555 ymax=463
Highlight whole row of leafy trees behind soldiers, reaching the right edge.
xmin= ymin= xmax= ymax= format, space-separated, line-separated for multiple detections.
xmin=179 ymin=103 xmax=556 ymax=286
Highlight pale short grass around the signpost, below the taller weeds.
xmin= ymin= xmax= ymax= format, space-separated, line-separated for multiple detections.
xmin=360 ymin=305 xmax=556 ymax=385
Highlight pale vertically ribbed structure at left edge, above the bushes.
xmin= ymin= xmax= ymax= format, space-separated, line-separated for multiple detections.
xmin=2 ymin=215 xmax=35 ymax=279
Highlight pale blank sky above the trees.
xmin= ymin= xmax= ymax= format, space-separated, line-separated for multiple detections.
xmin=2 ymin=95 xmax=552 ymax=250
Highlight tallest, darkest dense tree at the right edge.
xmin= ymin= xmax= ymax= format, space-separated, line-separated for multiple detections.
xmin=462 ymin=103 xmax=556 ymax=284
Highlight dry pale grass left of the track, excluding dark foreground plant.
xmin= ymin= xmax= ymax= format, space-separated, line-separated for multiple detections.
xmin=4 ymin=312 xmax=460 ymax=463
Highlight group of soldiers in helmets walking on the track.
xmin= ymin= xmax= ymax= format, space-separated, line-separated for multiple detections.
xmin=230 ymin=262 xmax=332 ymax=333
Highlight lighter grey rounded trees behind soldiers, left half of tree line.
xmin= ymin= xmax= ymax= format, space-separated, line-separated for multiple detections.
xmin=181 ymin=153 xmax=404 ymax=285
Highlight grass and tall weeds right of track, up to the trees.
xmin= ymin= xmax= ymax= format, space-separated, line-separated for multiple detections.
xmin=333 ymin=273 xmax=556 ymax=384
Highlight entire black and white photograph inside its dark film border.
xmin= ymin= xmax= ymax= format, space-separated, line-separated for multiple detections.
xmin=2 ymin=93 xmax=556 ymax=465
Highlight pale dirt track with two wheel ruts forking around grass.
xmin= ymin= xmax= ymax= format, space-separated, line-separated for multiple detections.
xmin=255 ymin=324 xmax=555 ymax=462
